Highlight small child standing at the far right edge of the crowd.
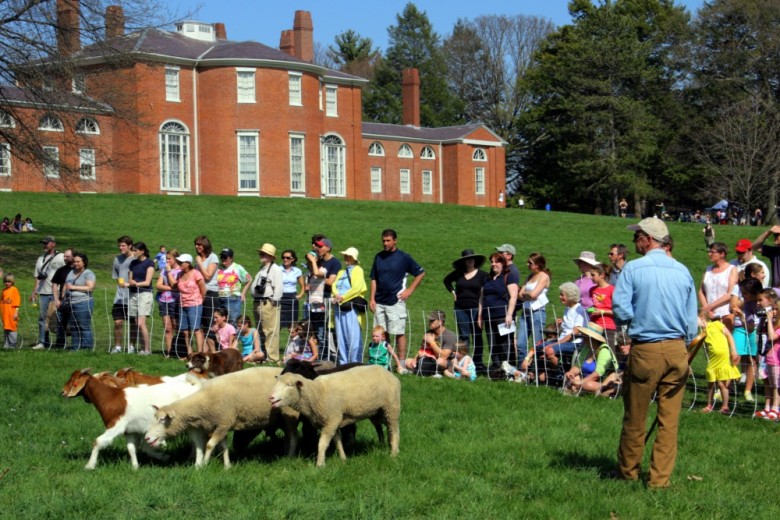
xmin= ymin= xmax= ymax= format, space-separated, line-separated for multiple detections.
xmin=755 ymin=289 xmax=780 ymax=421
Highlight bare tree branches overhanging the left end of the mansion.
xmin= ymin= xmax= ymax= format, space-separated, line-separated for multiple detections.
xmin=0 ymin=0 xmax=177 ymax=191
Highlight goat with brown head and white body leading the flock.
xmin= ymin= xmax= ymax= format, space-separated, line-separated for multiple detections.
xmin=62 ymin=368 xmax=200 ymax=469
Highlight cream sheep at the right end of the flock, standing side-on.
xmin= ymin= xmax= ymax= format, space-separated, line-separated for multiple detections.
xmin=269 ymin=365 xmax=401 ymax=466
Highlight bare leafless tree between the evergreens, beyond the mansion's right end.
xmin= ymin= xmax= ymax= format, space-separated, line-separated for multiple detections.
xmin=444 ymin=15 xmax=554 ymax=193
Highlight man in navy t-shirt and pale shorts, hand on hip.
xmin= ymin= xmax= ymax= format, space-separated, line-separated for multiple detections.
xmin=368 ymin=229 xmax=425 ymax=372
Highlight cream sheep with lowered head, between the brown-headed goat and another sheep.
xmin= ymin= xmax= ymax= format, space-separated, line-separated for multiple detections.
xmin=145 ymin=367 xmax=298 ymax=468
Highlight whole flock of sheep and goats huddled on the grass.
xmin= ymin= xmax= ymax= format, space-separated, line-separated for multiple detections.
xmin=62 ymin=356 xmax=401 ymax=469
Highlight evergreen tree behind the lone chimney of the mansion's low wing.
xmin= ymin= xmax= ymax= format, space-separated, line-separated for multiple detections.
xmin=363 ymin=3 xmax=463 ymax=127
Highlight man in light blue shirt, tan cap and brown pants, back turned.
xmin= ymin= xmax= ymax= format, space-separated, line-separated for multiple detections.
xmin=612 ymin=217 xmax=698 ymax=488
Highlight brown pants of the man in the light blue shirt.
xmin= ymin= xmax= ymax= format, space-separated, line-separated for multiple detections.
xmin=618 ymin=339 xmax=688 ymax=487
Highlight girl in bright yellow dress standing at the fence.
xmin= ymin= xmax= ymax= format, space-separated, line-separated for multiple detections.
xmin=699 ymin=310 xmax=740 ymax=415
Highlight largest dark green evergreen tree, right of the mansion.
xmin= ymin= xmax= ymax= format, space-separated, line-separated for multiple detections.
xmin=522 ymin=0 xmax=688 ymax=214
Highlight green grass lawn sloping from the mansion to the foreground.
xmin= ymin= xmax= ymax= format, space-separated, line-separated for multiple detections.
xmin=0 ymin=193 xmax=780 ymax=519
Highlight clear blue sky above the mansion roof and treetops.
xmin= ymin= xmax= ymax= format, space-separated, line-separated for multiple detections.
xmin=175 ymin=0 xmax=704 ymax=50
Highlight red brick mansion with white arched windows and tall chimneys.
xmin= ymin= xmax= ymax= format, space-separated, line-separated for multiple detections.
xmin=0 ymin=4 xmax=505 ymax=206
